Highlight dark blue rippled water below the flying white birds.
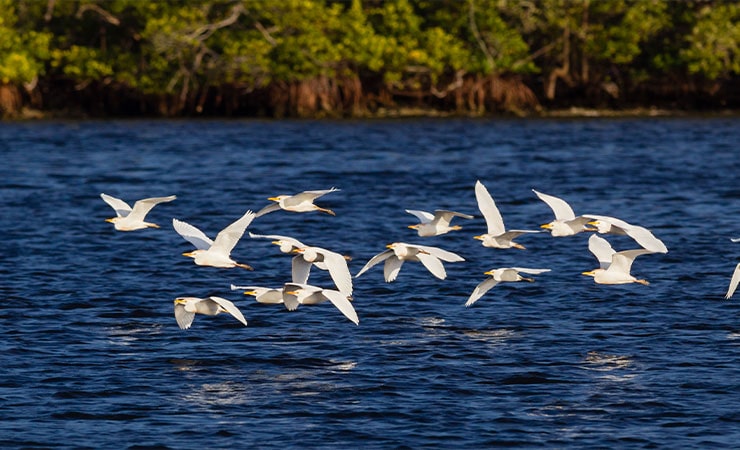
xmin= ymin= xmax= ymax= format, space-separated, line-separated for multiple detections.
xmin=0 ymin=118 xmax=740 ymax=449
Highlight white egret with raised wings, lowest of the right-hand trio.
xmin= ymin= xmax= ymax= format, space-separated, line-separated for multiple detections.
xmin=583 ymin=234 xmax=653 ymax=285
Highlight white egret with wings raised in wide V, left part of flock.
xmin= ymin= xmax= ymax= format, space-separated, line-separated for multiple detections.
xmin=172 ymin=211 xmax=255 ymax=270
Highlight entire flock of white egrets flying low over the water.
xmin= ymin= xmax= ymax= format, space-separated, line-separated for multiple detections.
xmin=100 ymin=181 xmax=740 ymax=329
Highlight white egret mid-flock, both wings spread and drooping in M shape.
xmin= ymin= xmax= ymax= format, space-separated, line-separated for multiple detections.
xmin=355 ymin=242 xmax=465 ymax=283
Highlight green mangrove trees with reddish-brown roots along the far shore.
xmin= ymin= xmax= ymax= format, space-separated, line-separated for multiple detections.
xmin=0 ymin=0 xmax=740 ymax=119
